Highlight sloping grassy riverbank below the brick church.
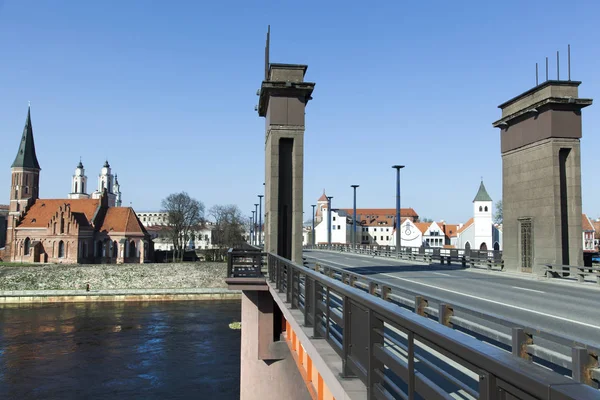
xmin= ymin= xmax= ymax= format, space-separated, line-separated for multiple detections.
xmin=0 ymin=262 xmax=227 ymax=290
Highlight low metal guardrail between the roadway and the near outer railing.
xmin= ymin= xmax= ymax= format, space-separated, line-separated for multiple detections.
xmin=305 ymin=257 xmax=600 ymax=387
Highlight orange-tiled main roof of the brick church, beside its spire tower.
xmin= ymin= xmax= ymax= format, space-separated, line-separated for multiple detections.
xmin=19 ymin=199 xmax=100 ymax=228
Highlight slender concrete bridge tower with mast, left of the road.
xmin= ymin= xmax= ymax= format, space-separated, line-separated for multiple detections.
xmin=258 ymin=32 xmax=315 ymax=264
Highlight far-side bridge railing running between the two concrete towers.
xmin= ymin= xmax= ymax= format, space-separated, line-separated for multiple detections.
xmin=304 ymin=244 xmax=504 ymax=270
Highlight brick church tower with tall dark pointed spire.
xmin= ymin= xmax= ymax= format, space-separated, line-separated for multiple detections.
xmin=6 ymin=107 xmax=41 ymax=256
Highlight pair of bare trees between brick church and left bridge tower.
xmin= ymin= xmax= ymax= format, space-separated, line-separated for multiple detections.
xmin=161 ymin=192 xmax=247 ymax=260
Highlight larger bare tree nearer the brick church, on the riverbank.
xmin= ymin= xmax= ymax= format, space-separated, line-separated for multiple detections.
xmin=162 ymin=192 xmax=204 ymax=260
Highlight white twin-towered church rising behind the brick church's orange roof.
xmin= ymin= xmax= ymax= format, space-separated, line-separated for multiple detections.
xmin=67 ymin=160 xmax=122 ymax=207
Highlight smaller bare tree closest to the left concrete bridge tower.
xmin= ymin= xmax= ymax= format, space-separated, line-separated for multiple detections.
xmin=208 ymin=204 xmax=247 ymax=258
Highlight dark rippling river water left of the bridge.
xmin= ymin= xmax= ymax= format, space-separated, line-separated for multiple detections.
xmin=0 ymin=301 xmax=240 ymax=400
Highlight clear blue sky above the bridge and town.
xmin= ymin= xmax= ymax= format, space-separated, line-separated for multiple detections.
xmin=0 ymin=0 xmax=600 ymax=223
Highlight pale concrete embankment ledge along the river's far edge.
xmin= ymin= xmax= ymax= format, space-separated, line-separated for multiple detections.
xmin=0 ymin=288 xmax=241 ymax=304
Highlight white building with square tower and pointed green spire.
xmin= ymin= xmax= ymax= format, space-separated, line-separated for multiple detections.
xmin=456 ymin=181 xmax=502 ymax=250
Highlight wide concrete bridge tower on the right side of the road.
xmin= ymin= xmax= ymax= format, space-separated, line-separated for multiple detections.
xmin=493 ymin=80 xmax=592 ymax=272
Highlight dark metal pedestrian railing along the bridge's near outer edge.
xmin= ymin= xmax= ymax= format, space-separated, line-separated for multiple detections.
xmin=231 ymin=250 xmax=600 ymax=400
